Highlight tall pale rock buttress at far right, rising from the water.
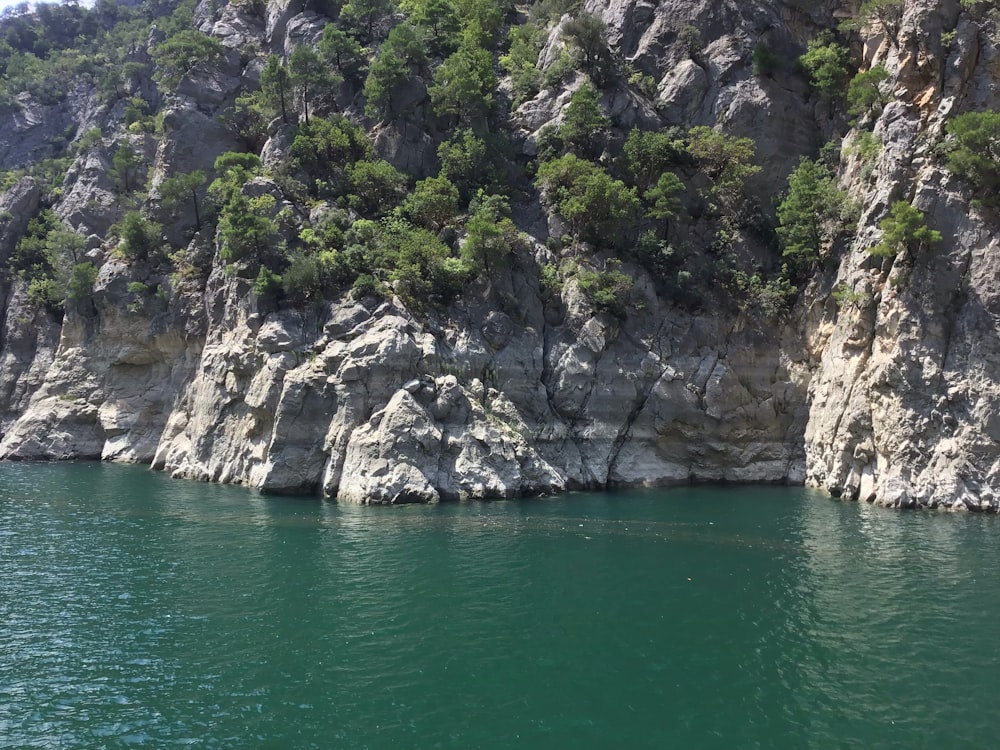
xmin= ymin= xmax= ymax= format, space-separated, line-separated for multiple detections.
xmin=805 ymin=3 xmax=1000 ymax=510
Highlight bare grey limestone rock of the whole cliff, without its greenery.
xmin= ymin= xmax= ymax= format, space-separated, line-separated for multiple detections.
xmin=0 ymin=0 xmax=1000 ymax=510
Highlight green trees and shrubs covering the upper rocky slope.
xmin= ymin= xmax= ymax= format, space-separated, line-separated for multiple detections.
xmin=0 ymin=0 xmax=952 ymax=324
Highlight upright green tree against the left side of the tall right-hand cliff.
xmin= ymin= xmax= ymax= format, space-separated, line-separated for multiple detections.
xmin=777 ymin=157 xmax=847 ymax=271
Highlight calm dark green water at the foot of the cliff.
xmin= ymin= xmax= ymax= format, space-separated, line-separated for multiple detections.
xmin=0 ymin=464 xmax=1000 ymax=750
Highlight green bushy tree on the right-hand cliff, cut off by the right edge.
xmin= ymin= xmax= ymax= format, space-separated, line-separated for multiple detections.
xmin=945 ymin=110 xmax=1000 ymax=205
